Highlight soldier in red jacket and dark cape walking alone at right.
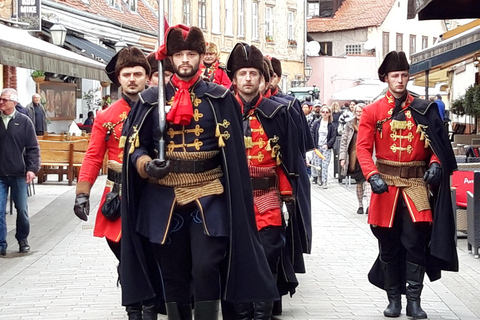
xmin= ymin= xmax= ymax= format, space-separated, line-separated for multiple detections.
xmin=357 ymin=51 xmax=458 ymax=319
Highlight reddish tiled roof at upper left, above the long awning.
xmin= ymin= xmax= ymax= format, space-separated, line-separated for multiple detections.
xmin=47 ymin=0 xmax=158 ymax=32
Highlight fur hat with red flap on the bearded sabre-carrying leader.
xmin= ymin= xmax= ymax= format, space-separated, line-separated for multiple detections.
xmin=156 ymin=24 xmax=206 ymax=60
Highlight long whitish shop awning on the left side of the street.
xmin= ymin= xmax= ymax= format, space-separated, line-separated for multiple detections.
xmin=0 ymin=24 xmax=109 ymax=81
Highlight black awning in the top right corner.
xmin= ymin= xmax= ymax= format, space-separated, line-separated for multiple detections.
xmin=407 ymin=0 xmax=480 ymax=20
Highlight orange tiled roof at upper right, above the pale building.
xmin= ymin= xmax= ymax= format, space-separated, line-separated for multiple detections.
xmin=307 ymin=0 xmax=396 ymax=33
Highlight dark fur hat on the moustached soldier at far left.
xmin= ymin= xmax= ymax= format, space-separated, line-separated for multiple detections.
xmin=105 ymin=47 xmax=150 ymax=86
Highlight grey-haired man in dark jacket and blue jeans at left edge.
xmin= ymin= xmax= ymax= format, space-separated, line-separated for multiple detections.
xmin=0 ymin=88 xmax=40 ymax=256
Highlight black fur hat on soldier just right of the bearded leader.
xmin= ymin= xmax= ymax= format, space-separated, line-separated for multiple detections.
xmin=226 ymin=42 xmax=264 ymax=80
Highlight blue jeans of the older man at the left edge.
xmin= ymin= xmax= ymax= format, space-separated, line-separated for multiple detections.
xmin=0 ymin=176 xmax=30 ymax=249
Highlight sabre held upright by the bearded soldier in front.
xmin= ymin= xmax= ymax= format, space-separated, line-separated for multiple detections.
xmin=158 ymin=0 xmax=168 ymax=162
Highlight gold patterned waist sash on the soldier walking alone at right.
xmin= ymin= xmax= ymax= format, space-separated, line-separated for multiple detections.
xmin=377 ymin=159 xmax=431 ymax=211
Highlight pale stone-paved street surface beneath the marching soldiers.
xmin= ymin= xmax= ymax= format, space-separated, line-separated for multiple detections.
xmin=0 ymin=174 xmax=480 ymax=320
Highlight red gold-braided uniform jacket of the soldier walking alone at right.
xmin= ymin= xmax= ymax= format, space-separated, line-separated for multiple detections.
xmin=357 ymin=91 xmax=439 ymax=227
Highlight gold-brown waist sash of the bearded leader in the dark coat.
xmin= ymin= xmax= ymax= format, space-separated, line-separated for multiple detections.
xmin=151 ymin=150 xmax=224 ymax=205
